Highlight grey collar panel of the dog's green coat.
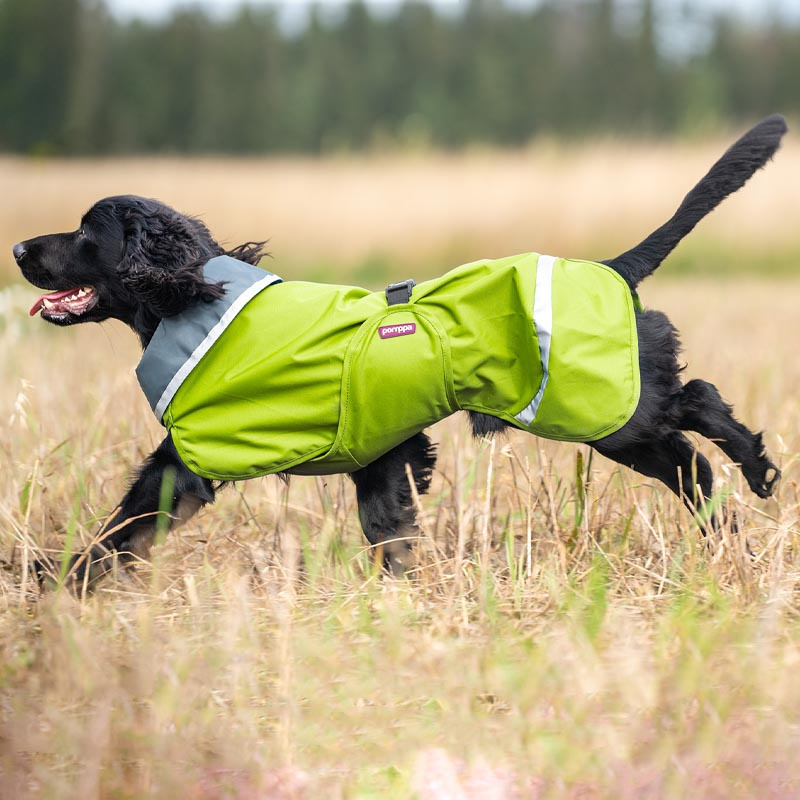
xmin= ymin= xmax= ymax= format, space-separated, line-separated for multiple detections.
xmin=136 ymin=256 xmax=281 ymax=421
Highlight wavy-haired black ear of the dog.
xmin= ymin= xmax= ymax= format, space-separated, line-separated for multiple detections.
xmin=119 ymin=201 xmax=225 ymax=317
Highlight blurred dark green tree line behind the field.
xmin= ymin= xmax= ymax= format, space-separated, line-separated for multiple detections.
xmin=0 ymin=0 xmax=800 ymax=155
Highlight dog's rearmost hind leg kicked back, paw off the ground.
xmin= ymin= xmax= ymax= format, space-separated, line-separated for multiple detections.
xmin=673 ymin=380 xmax=781 ymax=497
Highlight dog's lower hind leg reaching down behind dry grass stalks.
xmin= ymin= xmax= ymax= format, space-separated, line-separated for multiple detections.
xmin=592 ymin=431 xmax=718 ymax=533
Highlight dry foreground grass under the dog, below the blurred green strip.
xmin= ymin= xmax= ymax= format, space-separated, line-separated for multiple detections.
xmin=0 ymin=281 xmax=800 ymax=800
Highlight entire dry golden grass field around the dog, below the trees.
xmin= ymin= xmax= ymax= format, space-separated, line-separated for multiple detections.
xmin=0 ymin=143 xmax=800 ymax=800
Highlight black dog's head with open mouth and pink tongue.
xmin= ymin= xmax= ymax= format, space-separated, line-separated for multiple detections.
xmin=13 ymin=195 xmax=263 ymax=341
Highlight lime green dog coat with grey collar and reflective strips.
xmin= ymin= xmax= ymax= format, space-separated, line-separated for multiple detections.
xmin=136 ymin=253 xmax=640 ymax=480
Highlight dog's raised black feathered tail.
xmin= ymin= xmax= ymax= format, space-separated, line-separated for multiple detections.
xmin=603 ymin=114 xmax=786 ymax=289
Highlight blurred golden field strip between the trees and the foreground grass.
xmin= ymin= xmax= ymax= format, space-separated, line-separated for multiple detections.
xmin=0 ymin=133 xmax=800 ymax=284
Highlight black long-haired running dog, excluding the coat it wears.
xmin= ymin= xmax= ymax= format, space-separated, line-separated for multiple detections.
xmin=13 ymin=116 xmax=786 ymax=582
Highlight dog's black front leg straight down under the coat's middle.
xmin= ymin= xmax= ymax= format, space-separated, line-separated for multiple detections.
xmin=350 ymin=433 xmax=436 ymax=575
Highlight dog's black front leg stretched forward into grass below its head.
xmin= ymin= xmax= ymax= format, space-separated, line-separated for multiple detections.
xmin=45 ymin=436 xmax=214 ymax=591
